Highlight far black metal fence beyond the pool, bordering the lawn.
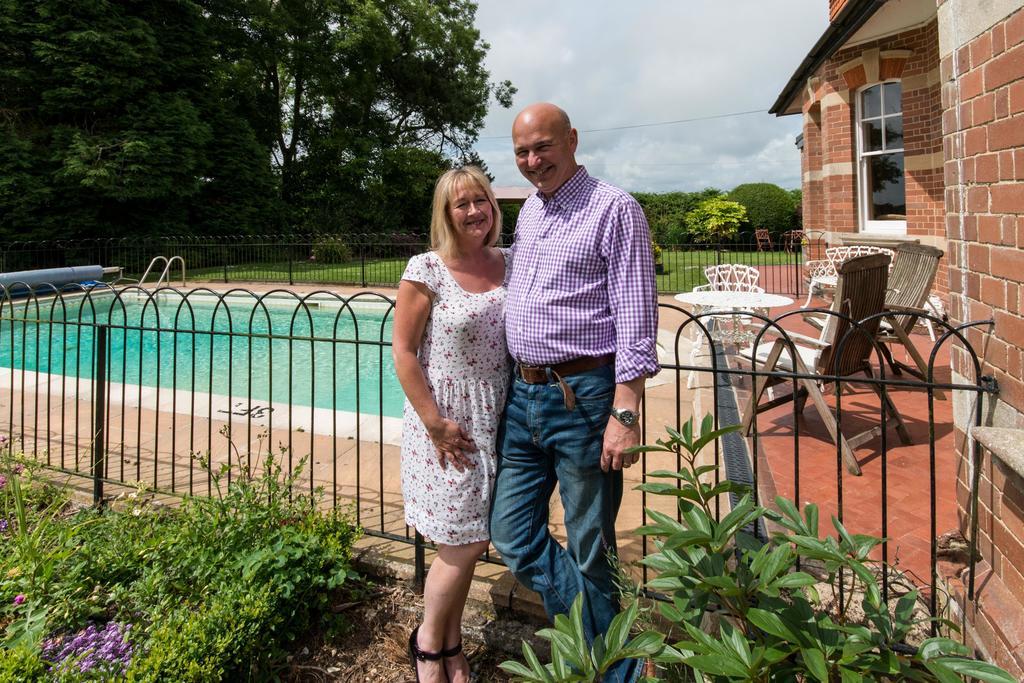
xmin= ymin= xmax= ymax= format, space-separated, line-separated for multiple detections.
xmin=0 ymin=233 xmax=804 ymax=295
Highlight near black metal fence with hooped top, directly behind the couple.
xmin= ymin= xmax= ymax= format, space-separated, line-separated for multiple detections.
xmin=0 ymin=286 xmax=993 ymax=626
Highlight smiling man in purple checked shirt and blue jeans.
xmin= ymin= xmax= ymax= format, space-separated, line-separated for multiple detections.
xmin=490 ymin=103 xmax=658 ymax=681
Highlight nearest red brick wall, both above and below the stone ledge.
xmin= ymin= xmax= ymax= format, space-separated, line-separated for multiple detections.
xmin=939 ymin=2 xmax=1024 ymax=680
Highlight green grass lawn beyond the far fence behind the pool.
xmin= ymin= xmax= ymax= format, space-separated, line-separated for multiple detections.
xmin=188 ymin=249 xmax=794 ymax=292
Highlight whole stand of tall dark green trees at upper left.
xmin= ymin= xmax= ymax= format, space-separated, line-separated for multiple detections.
xmin=0 ymin=0 xmax=515 ymax=239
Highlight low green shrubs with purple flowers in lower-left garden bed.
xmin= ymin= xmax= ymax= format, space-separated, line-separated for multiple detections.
xmin=0 ymin=448 xmax=358 ymax=681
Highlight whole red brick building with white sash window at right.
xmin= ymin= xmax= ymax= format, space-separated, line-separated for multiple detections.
xmin=771 ymin=0 xmax=1024 ymax=680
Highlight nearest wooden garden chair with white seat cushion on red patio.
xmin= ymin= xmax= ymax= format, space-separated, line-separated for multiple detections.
xmin=740 ymin=254 xmax=911 ymax=474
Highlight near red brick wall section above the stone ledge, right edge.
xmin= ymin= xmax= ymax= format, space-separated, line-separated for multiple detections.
xmin=941 ymin=10 xmax=1024 ymax=419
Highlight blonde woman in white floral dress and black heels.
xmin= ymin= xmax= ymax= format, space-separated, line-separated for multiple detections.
xmin=392 ymin=166 xmax=511 ymax=683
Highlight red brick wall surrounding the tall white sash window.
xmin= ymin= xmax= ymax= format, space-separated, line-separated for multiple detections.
xmin=804 ymin=22 xmax=948 ymax=291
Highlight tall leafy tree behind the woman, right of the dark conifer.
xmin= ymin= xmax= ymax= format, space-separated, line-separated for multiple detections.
xmin=219 ymin=0 xmax=515 ymax=231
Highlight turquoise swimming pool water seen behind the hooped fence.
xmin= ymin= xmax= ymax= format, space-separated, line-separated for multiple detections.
xmin=0 ymin=296 xmax=402 ymax=417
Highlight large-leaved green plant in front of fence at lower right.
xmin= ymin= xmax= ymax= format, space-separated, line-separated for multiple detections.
xmin=504 ymin=416 xmax=1014 ymax=683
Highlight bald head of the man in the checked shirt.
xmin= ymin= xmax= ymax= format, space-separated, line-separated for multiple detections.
xmin=512 ymin=102 xmax=579 ymax=197
